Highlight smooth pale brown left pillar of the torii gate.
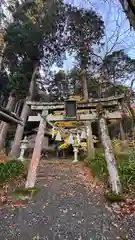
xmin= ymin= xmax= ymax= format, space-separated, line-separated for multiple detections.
xmin=25 ymin=111 xmax=47 ymax=188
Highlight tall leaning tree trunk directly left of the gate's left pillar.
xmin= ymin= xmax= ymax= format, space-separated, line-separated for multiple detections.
xmin=11 ymin=64 xmax=38 ymax=158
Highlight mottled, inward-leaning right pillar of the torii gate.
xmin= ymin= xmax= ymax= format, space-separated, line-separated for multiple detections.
xmin=97 ymin=104 xmax=121 ymax=194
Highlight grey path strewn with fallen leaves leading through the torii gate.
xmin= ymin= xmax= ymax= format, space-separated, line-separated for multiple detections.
xmin=0 ymin=163 xmax=135 ymax=240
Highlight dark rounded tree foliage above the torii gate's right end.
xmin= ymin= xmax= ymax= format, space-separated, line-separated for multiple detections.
xmin=98 ymin=49 xmax=135 ymax=97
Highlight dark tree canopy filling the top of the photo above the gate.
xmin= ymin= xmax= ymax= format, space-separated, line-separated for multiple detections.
xmin=2 ymin=0 xmax=134 ymax=103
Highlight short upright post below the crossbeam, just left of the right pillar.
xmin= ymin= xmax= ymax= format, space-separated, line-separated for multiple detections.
xmin=87 ymin=121 xmax=95 ymax=159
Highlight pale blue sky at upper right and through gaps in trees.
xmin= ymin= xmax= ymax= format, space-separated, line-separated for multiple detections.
xmin=54 ymin=0 xmax=135 ymax=71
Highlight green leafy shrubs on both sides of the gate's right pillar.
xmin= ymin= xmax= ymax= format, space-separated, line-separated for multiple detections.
xmin=88 ymin=149 xmax=135 ymax=190
